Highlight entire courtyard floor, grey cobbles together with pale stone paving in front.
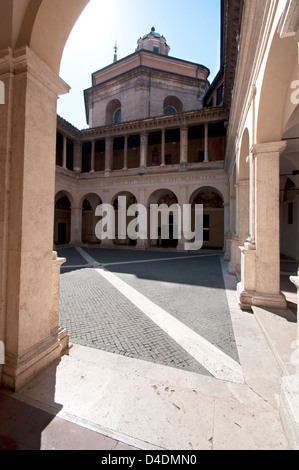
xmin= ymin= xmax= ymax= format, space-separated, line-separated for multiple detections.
xmin=0 ymin=247 xmax=297 ymax=450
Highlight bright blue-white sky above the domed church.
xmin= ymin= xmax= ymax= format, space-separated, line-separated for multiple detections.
xmin=57 ymin=0 xmax=220 ymax=129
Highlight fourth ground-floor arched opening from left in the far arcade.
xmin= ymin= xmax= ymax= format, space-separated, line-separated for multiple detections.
xmin=148 ymin=188 xmax=180 ymax=248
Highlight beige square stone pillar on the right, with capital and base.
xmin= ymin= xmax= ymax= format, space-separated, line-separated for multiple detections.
xmin=238 ymin=142 xmax=286 ymax=309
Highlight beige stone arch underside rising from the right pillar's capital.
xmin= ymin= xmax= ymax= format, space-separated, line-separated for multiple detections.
xmin=256 ymin=33 xmax=298 ymax=143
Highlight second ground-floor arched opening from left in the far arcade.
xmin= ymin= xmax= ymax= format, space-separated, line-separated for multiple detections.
xmin=82 ymin=194 xmax=102 ymax=243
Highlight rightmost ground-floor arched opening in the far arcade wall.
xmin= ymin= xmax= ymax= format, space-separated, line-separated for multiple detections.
xmin=189 ymin=187 xmax=224 ymax=249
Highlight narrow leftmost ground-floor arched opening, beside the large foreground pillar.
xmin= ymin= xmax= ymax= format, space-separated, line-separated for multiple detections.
xmin=54 ymin=191 xmax=71 ymax=245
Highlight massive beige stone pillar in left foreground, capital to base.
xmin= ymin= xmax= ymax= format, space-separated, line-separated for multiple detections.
xmin=0 ymin=47 xmax=69 ymax=391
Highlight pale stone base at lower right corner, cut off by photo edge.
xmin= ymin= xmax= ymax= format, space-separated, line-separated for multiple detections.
xmin=279 ymin=375 xmax=299 ymax=450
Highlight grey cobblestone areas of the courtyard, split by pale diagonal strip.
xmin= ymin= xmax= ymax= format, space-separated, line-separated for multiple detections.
xmin=58 ymin=248 xmax=238 ymax=375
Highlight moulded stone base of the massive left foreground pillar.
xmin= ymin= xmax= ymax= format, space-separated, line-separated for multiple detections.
xmin=1 ymin=328 xmax=69 ymax=392
